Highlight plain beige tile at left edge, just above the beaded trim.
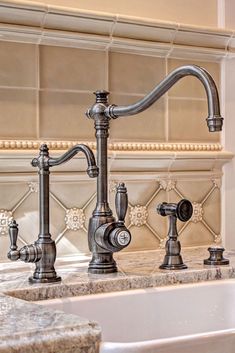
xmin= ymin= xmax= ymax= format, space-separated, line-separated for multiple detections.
xmin=0 ymin=89 xmax=37 ymax=139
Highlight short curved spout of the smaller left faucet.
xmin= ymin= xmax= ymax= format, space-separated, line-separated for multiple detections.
xmin=48 ymin=144 xmax=98 ymax=178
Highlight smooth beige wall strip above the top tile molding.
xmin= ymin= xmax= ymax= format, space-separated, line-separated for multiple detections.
xmin=31 ymin=0 xmax=218 ymax=26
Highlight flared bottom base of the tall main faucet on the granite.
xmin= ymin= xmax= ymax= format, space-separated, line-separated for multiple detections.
xmin=88 ymin=253 xmax=118 ymax=274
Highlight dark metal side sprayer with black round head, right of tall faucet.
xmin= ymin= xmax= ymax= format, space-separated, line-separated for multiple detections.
xmin=157 ymin=199 xmax=193 ymax=270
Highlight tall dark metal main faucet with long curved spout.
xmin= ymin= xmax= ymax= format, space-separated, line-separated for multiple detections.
xmin=86 ymin=65 xmax=223 ymax=273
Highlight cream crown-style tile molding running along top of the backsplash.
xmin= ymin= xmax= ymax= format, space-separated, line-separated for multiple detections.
xmin=0 ymin=0 xmax=235 ymax=60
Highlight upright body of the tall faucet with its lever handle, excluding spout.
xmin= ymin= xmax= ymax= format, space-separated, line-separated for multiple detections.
xmin=87 ymin=91 xmax=131 ymax=273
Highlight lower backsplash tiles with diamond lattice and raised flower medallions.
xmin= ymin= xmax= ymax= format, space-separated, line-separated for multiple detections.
xmin=0 ymin=173 xmax=221 ymax=259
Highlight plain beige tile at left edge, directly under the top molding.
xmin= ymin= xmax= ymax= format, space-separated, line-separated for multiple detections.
xmin=0 ymin=41 xmax=37 ymax=87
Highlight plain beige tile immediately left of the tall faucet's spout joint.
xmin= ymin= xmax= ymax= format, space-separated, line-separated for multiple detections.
xmin=40 ymin=91 xmax=95 ymax=140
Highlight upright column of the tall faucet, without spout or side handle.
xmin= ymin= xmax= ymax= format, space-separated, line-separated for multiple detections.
xmin=87 ymin=91 xmax=117 ymax=273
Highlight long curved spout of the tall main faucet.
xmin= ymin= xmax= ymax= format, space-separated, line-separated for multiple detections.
xmin=104 ymin=65 xmax=223 ymax=132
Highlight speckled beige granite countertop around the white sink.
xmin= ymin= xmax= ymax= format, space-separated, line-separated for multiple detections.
xmin=0 ymin=248 xmax=235 ymax=353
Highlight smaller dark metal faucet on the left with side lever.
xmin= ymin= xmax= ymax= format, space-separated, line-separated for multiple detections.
xmin=8 ymin=144 xmax=98 ymax=283
